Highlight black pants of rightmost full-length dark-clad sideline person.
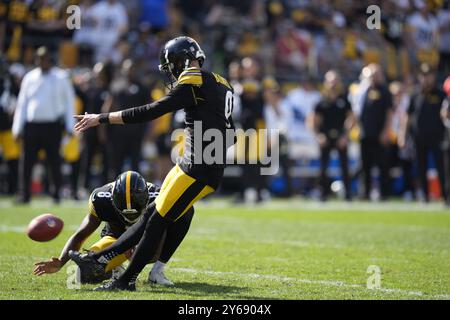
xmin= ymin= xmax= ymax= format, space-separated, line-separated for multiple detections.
xmin=416 ymin=139 xmax=448 ymax=201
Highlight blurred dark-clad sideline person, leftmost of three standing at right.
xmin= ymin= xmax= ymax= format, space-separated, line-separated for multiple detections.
xmin=312 ymin=70 xmax=354 ymax=201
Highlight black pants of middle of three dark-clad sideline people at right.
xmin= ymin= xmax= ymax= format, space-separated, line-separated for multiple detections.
xmin=361 ymin=139 xmax=390 ymax=199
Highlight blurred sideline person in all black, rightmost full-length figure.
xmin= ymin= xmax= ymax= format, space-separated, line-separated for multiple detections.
xmin=408 ymin=64 xmax=448 ymax=202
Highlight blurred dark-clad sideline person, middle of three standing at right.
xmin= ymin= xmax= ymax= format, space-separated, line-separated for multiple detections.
xmin=359 ymin=64 xmax=393 ymax=199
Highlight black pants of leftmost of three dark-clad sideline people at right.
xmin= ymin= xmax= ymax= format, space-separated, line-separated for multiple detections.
xmin=320 ymin=142 xmax=351 ymax=199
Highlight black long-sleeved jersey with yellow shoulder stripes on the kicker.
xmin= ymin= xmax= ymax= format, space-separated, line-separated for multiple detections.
xmin=122 ymin=68 xmax=235 ymax=189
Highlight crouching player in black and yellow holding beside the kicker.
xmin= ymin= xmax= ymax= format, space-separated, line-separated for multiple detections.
xmin=34 ymin=171 xmax=194 ymax=285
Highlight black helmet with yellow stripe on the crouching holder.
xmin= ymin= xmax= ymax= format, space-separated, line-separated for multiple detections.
xmin=112 ymin=171 xmax=149 ymax=225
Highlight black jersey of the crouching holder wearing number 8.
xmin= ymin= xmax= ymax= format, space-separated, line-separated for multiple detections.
xmin=89 ymin=182 xmax=160 ymax=238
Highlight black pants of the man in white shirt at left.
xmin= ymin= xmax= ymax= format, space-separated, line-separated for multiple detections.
xmin=19 ymin=122 xmax=63 ymax=201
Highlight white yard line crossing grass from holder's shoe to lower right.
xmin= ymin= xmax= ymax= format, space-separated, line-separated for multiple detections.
xmin=170 ymin=268 xmax=450 ymax=299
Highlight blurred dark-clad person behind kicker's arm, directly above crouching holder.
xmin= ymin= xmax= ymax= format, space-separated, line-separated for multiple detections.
xmin=107 ymin=60 xmax=150 ymax=176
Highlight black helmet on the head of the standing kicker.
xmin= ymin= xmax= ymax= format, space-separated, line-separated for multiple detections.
xmin=159 ymin=36 xmax=206 ymax=85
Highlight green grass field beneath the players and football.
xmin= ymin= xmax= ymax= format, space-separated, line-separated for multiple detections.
xmin=0 ymin=199 xmax=450 ymax=299
